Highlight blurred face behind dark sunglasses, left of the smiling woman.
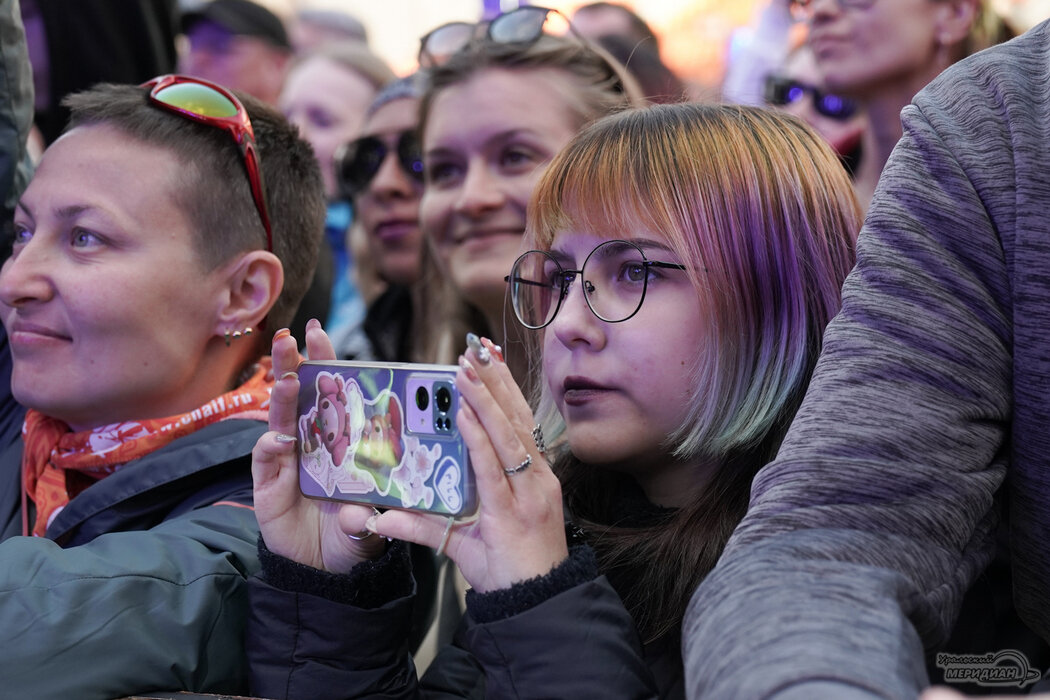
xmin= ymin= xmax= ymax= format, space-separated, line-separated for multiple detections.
xmin=354 ymin=98 xmax=423 ymax=284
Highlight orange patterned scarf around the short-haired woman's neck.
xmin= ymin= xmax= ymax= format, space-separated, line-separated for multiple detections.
xmin=22 ymin=357 xmax=273 ymax=537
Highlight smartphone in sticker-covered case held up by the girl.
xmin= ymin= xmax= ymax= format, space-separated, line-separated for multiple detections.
xmin=298 ymin=360 xmax=478 ymax=517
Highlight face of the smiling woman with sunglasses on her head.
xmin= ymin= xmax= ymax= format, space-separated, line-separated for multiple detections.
xmin=421 ymin=68 xmax=579 ymax=318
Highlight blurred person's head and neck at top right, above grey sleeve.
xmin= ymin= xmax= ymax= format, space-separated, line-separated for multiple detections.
xmin=790 ymin=0 xmax=1012 ymax=210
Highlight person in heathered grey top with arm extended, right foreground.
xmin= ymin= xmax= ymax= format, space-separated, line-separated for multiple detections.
xmin=683 ymin=16 xmax=1050 ymax=698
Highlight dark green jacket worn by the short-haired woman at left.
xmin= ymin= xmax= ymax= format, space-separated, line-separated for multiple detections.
xmin=0 ymin=420 xmax=266 ymax=700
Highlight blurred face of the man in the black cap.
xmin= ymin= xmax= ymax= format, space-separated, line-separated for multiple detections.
xmin=179 ymin=20 xmax=289 ymax=105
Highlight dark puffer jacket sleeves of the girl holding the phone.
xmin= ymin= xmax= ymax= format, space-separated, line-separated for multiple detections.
xmin=248 ymin=543 xmax=684 ymax=700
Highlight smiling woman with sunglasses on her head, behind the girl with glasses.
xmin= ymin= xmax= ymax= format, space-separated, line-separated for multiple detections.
xmin=407 ymin=7 xmax=644 ymax=379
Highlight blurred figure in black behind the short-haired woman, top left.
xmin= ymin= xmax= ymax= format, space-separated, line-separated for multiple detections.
xmin=22 ymin=0 xmax=179 ymax=147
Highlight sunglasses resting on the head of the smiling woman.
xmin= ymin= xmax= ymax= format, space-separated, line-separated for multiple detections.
xmin=418 ymin=5 xmax=583 ymax=68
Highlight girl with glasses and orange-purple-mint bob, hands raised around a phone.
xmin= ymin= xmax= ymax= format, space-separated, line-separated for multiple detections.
xmin=248 ymin=104 xmax=860 ymax=698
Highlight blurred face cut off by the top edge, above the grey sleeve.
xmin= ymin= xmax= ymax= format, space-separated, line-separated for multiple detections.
xmin=807 ymin=0 xmax=945 ymax=98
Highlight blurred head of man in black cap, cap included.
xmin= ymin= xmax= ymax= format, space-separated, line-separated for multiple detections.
xmin=180 ymin=0 xmax=292 ymax=105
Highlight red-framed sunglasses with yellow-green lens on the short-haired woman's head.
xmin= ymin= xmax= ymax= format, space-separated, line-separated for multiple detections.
xmin=142 ymin=73 xmax=273 ymax=253
